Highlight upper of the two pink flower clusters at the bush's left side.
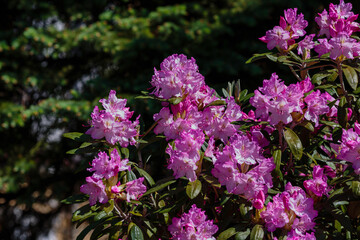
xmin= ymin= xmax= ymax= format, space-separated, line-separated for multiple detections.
xmin=86 ymin=90 xmax=139 ymax=147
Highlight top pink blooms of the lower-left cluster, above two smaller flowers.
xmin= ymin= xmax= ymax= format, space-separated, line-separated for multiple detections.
xmin=87 ymin=149 xmax=130 ymax=179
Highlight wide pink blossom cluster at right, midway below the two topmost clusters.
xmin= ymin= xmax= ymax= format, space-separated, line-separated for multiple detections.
xmin=250 ymin=73 xmax=330 ymax=126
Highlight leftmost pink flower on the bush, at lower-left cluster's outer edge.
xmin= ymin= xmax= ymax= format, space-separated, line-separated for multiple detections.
xmin=80 ymin=177 xmax=109 ymax=206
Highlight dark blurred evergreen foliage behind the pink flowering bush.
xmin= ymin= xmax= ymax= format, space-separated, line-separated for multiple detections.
xmin=0 ymin=0 xmax=359 ymax=240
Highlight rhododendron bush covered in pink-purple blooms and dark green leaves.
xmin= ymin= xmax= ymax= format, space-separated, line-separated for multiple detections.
xmin=64 ymin=0 xmax=360 ymax=240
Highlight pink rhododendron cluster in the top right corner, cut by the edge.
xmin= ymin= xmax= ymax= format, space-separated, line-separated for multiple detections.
xmin=315 ymin=0 xmax=360 ymax=60
